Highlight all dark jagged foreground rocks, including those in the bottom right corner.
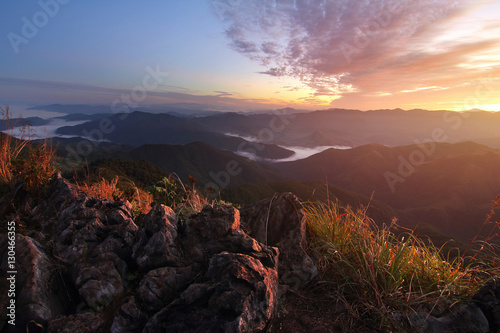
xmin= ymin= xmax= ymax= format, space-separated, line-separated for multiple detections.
xmin=4 ymin=176 xmax=500 ymax=333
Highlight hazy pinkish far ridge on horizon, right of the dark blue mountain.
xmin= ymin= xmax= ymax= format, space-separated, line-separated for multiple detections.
xmin=186 ymin=109 xmax=500 ymax=147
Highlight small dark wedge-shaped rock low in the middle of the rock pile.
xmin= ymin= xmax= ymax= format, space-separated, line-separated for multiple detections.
xmin=137 ymin=266 xmax=199 ymax=313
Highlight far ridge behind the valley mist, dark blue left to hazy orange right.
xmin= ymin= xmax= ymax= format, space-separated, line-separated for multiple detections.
xmin=50 ymin=109 xmax=500 ymax=150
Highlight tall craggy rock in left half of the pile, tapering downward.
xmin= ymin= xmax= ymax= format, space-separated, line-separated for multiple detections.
xmin=56 ymin=197 xmax=138 ymax=309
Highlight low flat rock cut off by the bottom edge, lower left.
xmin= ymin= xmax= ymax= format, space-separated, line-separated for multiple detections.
xmin=48 ymin=312 xmax=106 ymax=333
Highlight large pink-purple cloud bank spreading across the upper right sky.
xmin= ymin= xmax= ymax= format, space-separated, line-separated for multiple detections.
xmin=211 ymin=0 xmax=500 ymax=98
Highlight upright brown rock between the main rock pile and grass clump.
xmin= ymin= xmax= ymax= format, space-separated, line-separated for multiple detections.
xmin=241 ymin=193 xmax=318 ymax=289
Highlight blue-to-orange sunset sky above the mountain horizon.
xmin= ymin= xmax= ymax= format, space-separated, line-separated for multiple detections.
xmin=0 ymin=0 xmax=500 ymax=111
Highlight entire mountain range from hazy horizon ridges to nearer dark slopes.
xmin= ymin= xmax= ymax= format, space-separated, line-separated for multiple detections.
xmin=17 ymin=109 xmax=500 ymax=239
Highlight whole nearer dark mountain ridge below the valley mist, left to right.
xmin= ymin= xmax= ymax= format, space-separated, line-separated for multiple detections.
xmin=47 ymin=130 xmax=500 ymax=239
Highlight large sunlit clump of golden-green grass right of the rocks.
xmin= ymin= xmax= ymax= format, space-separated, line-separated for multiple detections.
xmin=306 ymin=200 xmax=498 ymax=331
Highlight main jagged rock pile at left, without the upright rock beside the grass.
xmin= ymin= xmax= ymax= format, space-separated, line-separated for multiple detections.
xmin=0 ymin=177 xmax=290 ymax=332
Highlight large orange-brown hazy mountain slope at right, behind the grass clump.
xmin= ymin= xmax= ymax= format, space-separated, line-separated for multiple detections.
xmin=276 ymin=142 xmax=500 ymax=237
